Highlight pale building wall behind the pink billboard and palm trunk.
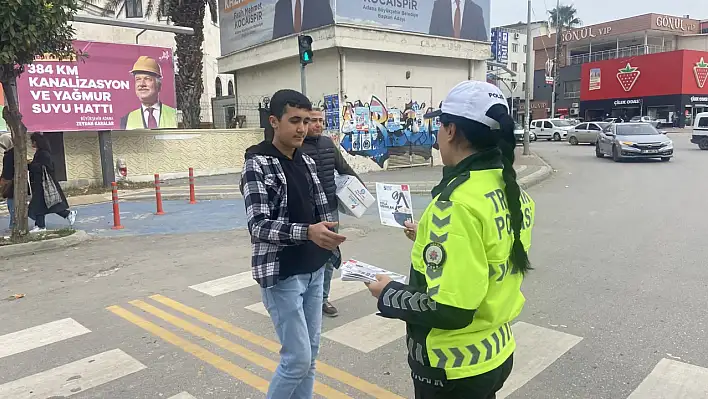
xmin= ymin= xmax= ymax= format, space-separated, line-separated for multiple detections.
xmin=73 ymin=3 xmax=233 ymax=123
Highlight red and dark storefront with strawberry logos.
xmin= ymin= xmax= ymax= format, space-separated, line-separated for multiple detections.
xmin=580 ymin=50 xmax=708 ymax=126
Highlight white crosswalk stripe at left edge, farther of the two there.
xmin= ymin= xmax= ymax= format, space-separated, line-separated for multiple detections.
xmin=0 ymin=319 xmax=91 ymax=359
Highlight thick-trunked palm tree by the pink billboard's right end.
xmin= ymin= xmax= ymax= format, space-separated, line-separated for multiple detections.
xmin=99 ymin=0 xmax=218 ymax=129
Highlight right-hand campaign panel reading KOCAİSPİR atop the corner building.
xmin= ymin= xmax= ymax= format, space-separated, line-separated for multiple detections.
xmin=334 ymin=0 xmax=491 ymax=41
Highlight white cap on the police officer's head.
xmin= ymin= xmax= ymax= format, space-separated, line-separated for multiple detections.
xmin=425 ymin=80 xmax=509 ymax=129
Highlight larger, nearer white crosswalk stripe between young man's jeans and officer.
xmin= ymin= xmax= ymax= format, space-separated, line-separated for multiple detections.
xmin=322 ymin=314 xmax=406 ymax=353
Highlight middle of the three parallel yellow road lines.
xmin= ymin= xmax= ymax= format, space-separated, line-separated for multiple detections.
xmin=129 ymin=300 xmax=351 ymax=399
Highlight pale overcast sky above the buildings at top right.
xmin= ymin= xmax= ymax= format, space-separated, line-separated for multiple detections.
xmin=491 ymin=0 xmax=708 ymax=26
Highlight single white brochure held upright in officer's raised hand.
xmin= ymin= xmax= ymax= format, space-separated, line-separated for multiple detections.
xmin=376 ymin=183 xmax=413 ymax=229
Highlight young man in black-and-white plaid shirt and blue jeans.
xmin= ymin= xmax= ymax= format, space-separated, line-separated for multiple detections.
xmin=241 ymin=90 xmax=346 ymax=399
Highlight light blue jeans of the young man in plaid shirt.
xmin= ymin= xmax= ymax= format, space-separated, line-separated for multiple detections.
xmin=261 ymin=268 xmax=324 ymax=399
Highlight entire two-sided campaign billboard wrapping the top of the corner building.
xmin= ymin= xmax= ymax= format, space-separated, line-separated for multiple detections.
xmin=219 ymin=0 xmax=491 ymax=56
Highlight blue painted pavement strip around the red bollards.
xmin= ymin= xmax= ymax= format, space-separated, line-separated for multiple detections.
xmin=0 ymin=195 xmax=429 ymax=236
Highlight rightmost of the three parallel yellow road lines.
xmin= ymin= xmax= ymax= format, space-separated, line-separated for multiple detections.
xmin=150 ymin=295 xmax=405 ymax=399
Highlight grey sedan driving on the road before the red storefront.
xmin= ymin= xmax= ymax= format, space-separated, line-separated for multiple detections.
xmin=595 ymin=123 xmax=674 ymax=162
